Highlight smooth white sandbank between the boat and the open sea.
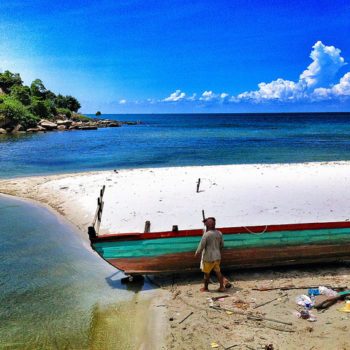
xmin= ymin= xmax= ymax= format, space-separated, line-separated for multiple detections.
xmin=0 ymin=162 xmax=350 ymax=233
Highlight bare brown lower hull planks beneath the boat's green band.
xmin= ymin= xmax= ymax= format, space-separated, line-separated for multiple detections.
xmin=106 ymin=245 xmax=350 ymax=275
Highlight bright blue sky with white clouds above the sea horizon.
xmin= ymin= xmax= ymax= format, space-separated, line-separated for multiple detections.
xmin=0 ymin=0 xmax=350 ymax=114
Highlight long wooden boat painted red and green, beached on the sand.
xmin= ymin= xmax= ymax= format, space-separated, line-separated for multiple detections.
xmin=89 ymin=186 xmax=350 ymax=275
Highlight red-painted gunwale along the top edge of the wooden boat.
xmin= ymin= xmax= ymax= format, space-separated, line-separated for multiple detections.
xmin=91 ymin=221 xmax=350 ymax=243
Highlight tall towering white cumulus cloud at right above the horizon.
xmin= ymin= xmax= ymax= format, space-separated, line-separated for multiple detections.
xmin=237 ymin=41 xmax=346 ymax=103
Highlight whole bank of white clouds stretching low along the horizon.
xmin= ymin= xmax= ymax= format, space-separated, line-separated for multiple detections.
xmin=119 ymin=41 xmax=350 ymax=106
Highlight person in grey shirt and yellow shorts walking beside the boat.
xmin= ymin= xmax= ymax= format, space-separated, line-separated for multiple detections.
xmin=195 ymin=217 xmax=225 ymax=292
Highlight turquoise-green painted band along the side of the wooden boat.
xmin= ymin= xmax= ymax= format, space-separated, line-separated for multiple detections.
xmin=93 ymin=228 xmax=350 ymax=259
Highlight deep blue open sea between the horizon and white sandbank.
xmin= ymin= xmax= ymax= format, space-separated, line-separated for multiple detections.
xmin=0 ymin=113 xmax=350 ymax=178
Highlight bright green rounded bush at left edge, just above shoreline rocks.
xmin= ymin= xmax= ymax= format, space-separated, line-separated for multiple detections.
xmin=0 ymin=96 xmax=39 ymax=128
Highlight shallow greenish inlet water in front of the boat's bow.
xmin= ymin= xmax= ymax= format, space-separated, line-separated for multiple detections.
xmin=0 ymin=196 xmax=153 ymax=349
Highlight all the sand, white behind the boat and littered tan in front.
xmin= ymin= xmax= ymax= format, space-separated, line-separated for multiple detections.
xmin=0 ymin=162 xmax=350 ymax=349
